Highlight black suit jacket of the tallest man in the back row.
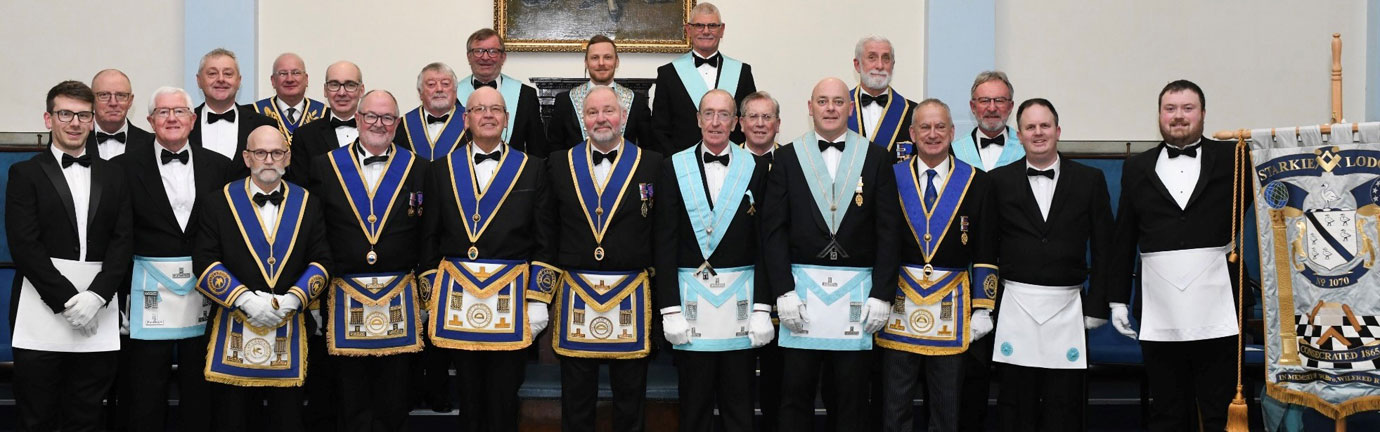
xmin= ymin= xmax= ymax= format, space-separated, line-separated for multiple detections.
xmin=651 ymin=57 xmax=758 ymax=155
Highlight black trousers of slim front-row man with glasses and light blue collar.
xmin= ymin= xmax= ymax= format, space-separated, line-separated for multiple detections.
xmin=675 ymin=349 xmax=756 ymax=432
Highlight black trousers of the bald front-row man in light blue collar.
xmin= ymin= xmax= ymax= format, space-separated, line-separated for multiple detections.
xmin=778 ymin=348 xmax=872 ymax=431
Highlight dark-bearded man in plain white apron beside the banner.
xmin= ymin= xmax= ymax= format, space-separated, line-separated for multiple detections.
xmin=1107 ymin=80 xmax=1250 ymax=431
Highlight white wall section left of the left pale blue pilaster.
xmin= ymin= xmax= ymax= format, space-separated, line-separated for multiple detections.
xmin=0 ymin=0 xmax=182 ymax=132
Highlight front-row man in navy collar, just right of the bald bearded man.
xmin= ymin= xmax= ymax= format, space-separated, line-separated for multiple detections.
xmin=310 ymin=89 xmax=426 ymax=431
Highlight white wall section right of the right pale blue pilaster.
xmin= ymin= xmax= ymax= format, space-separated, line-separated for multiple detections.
xmin=996 ymin=0 xmax=1380 ymax=141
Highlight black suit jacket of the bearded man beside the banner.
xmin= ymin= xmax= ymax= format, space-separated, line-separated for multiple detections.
xmin=1107 ymin=138 xmax=1252 ymax=309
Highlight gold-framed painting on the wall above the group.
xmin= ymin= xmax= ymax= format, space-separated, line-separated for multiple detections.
xmin=494 ymin=0 xmax=696 ymax=52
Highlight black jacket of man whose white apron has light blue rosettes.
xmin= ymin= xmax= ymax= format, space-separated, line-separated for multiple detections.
xmin=988 ymin=156 xmax=1112 ymax=319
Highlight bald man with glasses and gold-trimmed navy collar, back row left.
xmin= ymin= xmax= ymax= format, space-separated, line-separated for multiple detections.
xmin=254 ymin=52 xmax=326 ymax=139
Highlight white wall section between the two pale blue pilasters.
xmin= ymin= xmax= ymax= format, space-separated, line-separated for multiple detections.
xmin=259 ymin=0 xmax=925 ymax=139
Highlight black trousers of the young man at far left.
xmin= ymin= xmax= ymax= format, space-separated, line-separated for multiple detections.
xmin=14 ymin=348 xmax=119 ymax=431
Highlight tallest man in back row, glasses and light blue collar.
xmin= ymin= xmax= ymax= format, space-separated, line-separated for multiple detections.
xmin=651 ymin=1 xmax=758 ymax=153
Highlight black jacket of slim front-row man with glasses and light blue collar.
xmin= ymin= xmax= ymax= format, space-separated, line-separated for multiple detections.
xmin=654 ymin=146 xmax=773 ymax=309
